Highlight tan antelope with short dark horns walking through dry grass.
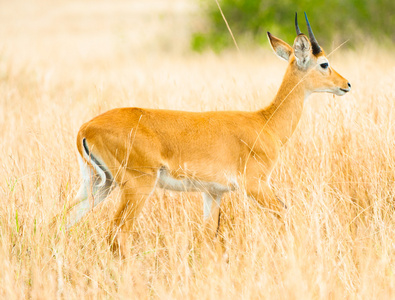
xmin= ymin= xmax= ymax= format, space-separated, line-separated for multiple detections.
xmin=57 ymin=13 xmax=351 ymax=253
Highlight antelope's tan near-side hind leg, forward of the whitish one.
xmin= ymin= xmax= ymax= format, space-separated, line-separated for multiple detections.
xmin=108 ymin=171 xmax=157 ymax=256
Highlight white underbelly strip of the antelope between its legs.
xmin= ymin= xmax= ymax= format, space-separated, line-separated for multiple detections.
xmin=158 ymin=168 xmax=236 ymax=195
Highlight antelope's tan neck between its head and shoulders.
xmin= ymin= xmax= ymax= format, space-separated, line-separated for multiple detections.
xmin=260 ymin=67 xmax=310 ymax=144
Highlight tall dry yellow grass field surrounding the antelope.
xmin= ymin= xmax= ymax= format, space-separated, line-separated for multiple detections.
xmin=0 ymin=1 xmax=395 ymax=299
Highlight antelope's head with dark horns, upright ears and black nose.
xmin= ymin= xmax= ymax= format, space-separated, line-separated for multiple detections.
xmin=267 ymin=13 xmax=351 ymax=96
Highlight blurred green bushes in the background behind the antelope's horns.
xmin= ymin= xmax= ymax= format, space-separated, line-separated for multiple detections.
xmin=191 ymin=0 xmax=395 ymax=52
